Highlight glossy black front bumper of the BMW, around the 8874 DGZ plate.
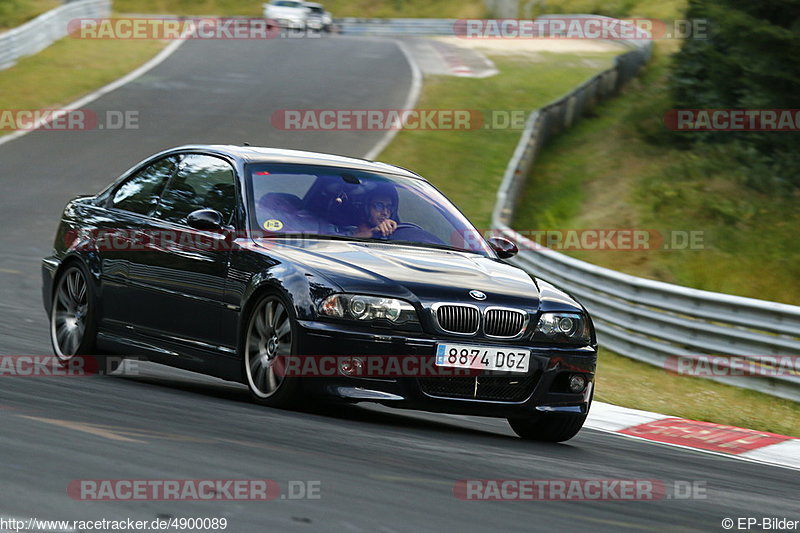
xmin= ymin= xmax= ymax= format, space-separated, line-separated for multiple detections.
xmin=299 ymin=321 xmax=597 ymax=418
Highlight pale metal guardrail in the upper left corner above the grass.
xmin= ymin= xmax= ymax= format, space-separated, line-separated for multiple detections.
xmin=0 ymin=0 xmax=111 ymax=70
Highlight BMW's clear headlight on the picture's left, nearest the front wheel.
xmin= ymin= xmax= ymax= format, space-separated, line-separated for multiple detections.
xmin=319 ymin=294 xmax=417 ymax=324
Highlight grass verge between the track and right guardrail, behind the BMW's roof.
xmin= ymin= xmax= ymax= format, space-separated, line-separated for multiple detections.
xmin=380 ymin=52 xmax=614 ymax=229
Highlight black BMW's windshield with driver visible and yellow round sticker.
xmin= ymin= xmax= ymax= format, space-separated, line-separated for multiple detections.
xmin=247 ymin=164 xmax=493 ymax=256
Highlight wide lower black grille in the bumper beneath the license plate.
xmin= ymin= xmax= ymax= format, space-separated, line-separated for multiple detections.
xmin=419 ymin=372 xmax=539 ymax=402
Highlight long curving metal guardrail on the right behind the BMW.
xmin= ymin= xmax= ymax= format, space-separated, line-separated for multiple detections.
xmin=492 ymin=19 xmax=800 ymax=401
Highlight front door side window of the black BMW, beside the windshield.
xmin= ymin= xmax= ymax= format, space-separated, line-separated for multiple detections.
xmin=156 ymin=154 xmax=236 ymax=224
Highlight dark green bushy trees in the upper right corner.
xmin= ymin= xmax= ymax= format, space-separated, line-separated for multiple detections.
xmin=670 ymin=0 xmax=800 ymax=192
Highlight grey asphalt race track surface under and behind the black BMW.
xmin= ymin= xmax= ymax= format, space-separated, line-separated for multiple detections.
xmin=0 ymin=37 xmax=800 ymax=532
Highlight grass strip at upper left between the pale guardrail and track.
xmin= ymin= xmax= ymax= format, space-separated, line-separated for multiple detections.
xmin=0 ymin=33 xmax=166 ymax=135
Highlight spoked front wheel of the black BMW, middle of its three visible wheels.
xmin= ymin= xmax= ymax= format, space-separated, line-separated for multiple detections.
xmin=241 ymin=294 xmax=302 ymax=408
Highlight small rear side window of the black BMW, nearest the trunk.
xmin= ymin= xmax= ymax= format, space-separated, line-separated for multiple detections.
xmin=111 ymin=157 xmax=178 ymax=215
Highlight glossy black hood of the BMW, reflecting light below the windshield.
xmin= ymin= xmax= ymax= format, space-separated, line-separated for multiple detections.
xmin=257 ymin=239 xmax=539 ymax=308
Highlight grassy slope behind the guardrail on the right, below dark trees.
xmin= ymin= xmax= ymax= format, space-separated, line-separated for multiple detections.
xmin=514 ymin=39 xmax=800 ymax=305
